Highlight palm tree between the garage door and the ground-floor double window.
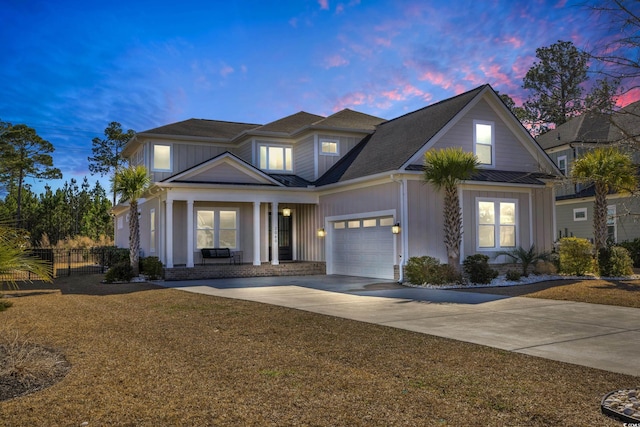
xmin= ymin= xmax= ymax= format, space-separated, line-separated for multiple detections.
xmin=424 ymin=147 xmax=479 ymax=270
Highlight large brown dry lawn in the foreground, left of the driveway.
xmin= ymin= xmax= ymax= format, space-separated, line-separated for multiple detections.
xmin=0 ymin=276 xmax=638 ymax=426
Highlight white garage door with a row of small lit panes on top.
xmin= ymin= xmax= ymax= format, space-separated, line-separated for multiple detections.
xmin=331 ymin=217 xmax=394 ymax=280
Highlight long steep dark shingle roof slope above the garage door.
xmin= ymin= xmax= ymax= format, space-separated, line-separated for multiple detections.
xmin=327 ymin=85 xmax=487 ymax=181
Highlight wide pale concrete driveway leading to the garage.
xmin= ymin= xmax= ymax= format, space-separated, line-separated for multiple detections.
xmin=158 ymin=276 xmax=640 ymax=376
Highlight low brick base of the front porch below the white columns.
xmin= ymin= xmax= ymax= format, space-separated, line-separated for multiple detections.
xmin=164 ymin=261 xmax=327 ymax=280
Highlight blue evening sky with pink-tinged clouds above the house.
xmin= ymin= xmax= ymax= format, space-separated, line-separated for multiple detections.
xmin=0 ymin=0 xmax=632 ymax=192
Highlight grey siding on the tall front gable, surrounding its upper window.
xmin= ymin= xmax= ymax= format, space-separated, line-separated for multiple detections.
xmin=433 ymin=100 xmax=539 ymax=172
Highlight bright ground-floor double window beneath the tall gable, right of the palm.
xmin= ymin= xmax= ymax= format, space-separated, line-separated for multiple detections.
xmin=477 ymin=199 xmax=518 ymax=250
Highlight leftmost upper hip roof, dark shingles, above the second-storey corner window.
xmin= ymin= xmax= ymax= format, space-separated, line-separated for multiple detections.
xmin=140 ymin=119 xmax=260 ymax=139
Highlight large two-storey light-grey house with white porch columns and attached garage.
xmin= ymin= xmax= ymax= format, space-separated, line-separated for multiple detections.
xmin=114 ymin=85 xmax=560 ymax=280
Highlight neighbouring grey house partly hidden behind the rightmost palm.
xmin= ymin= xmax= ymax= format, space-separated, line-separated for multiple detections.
xmin=537 ymin=101 xmax=640 ymax=246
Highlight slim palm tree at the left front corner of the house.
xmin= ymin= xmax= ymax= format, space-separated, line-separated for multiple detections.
xmin=113 ymin=166 xmax=151 ymax=276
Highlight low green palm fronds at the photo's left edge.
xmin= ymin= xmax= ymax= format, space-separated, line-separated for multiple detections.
xmin=0 ymin=224 xmax=53 ymax=289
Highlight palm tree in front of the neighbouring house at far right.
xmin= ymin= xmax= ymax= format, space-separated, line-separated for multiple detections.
xmin=571 ymin=146 xmax=638 ymax=253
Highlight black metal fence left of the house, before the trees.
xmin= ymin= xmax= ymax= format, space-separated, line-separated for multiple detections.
xmin=0 ymin=247 xmax=129 ymax=282
